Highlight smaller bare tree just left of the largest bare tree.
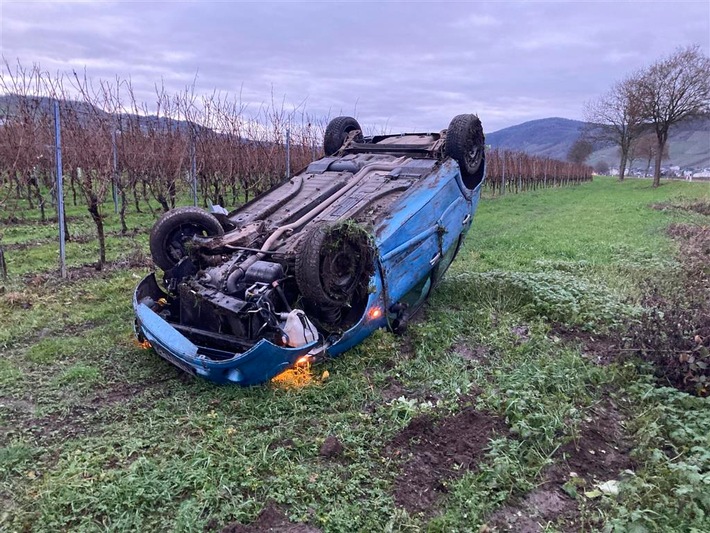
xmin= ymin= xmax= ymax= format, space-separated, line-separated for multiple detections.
xmin=584 ymin=77 xmax=643 ymax=181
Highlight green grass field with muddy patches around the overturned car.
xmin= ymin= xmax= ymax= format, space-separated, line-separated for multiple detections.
xmin=0 ymin=178 xmax=710 ymax=532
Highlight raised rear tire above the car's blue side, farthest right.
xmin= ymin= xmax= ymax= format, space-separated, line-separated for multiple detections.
xmin=446 ymin=115 xmax=486 ymax=189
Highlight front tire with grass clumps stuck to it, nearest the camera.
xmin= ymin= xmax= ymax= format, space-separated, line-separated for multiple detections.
xmin=296 ymin=224 xmax=374 ymax=307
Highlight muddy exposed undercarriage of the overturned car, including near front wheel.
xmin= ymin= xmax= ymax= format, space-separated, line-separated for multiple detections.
xmin=147 ymin=150 xmax=444 ymax=349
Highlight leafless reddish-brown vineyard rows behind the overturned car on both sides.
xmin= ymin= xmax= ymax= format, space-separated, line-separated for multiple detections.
xmin=0 ymin=64 xmax=591 ymax=264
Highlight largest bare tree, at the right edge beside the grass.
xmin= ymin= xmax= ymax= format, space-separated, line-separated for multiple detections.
xmin=635 ymin=45 xmax=710 ymax=187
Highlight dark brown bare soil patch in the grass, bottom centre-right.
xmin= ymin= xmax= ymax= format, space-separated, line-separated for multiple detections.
xmin=388 ymin=407 xmax=507 ymax=514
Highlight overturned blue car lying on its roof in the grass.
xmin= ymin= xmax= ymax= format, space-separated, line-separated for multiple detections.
xmin=133 ymin=115 xmax=485 ymax=386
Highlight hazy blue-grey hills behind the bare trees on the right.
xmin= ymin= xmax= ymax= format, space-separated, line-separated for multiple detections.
xmin=486 ymin=117 xmax=710 ymax=168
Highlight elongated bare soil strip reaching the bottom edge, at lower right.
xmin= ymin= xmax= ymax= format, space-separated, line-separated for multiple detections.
xmin=486 ymin=400 xmax=634 ymax=533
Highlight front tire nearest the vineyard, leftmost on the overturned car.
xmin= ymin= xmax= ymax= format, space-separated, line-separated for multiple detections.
xmin=150 ymin=207 xmax=224 ymax=270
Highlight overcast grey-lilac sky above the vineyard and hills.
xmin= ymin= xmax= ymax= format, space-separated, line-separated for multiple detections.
xmin=0 ymin=0 xmax=710 ymax=131
